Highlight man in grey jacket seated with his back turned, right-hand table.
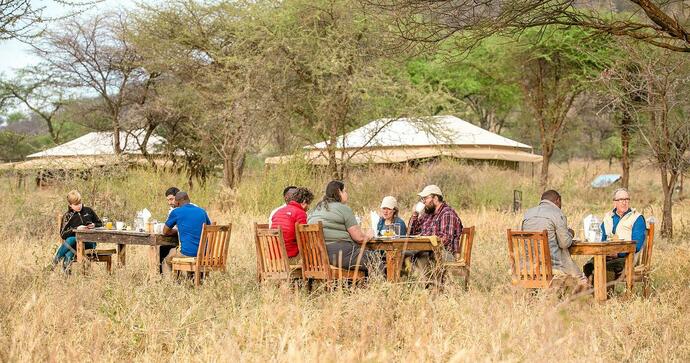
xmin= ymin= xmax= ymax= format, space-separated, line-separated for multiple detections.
xmin=522 ymin=190 xmax=587 ymax=285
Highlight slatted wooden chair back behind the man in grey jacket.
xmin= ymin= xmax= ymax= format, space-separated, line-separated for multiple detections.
xmin=508 ymin=229 xmax=553 ymax=288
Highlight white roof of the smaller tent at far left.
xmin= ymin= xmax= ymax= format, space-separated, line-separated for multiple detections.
xmin=27 ymin=129 xmax=165 ymax=159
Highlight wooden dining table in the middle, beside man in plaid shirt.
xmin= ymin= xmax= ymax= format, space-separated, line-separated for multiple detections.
xmin=365 ymin=236 xmax=443 ymax=282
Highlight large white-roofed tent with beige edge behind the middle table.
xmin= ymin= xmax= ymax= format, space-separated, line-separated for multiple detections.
xmin=266 ymin=116 xmax=542 ymax=165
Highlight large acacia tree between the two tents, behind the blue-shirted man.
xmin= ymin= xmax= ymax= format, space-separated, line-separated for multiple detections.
xmin=129 ymin=0 xmax=270 ymax=189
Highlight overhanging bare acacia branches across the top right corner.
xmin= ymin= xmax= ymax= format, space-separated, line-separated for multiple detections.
xmin=364 ymin=0 xmax=690 ymax=52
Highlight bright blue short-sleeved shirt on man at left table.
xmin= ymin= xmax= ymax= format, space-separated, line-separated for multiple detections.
xmin=165 ymin=203 xmax=211 ymax=257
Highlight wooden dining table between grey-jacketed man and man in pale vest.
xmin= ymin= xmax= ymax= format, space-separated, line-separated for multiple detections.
xmin=569 ymin=241 xmax=635 ymax=301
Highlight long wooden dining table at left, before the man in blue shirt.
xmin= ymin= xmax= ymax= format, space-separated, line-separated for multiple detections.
xmin=75 ymin=228 xmax=178 ymax=275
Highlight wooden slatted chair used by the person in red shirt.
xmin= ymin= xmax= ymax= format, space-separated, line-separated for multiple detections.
xmin=254 ymin=223 xmax=302 ymax=282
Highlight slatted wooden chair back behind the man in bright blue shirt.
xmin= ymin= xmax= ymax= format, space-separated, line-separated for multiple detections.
xmin=196 ymin=224 xmax=232 ymax=271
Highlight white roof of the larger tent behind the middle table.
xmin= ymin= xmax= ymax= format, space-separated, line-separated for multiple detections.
xmin=305 ymin=116 xmax=532 ymax=151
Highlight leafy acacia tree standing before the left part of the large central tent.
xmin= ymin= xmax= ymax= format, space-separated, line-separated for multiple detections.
xmin=265 ymin=0 xmax=430 ymax=179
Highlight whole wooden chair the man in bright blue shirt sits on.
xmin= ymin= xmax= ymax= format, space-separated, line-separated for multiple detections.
xmin=172 ymin=224 xmax=232 ymax=286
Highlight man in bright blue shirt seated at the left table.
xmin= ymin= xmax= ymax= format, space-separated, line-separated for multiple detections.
xmin=163 ymin=192 xmax=211 ymax=274
